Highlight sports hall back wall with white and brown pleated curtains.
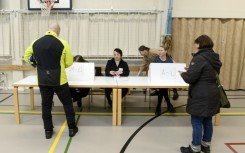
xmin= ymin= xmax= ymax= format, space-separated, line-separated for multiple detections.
xmin=0 ymin=0 xmax=245 ymax=90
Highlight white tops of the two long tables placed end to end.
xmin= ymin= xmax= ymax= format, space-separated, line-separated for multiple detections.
xmin=13 ymin=75 xmax=189 ymax=88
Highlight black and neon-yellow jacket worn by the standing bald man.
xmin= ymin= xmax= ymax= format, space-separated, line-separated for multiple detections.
xmin=24 ymin=31 xmax=73 ymax=86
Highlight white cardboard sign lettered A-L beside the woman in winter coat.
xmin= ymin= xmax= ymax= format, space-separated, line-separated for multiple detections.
xmin=148 ymin=63 xmax=186 ymax=83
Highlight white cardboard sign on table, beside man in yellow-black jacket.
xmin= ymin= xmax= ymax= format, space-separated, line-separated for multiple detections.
xmin=66 ymin=62 xmax=95 ymax=81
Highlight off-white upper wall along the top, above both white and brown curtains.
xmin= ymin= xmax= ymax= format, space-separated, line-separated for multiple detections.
xmin=0 ymin=0 xmax=245 ymax=18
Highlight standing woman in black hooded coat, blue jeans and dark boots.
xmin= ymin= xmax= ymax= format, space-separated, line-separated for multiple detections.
xmin=180 ymin=35 xmax=222 ymax=153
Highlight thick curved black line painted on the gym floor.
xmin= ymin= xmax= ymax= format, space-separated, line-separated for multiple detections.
xmin=120 ymin=104 xmax=186 ymax=153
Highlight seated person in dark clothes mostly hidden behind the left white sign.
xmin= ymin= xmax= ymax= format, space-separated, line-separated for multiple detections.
xmin=70 ymin=55 xmax=90 ymax=107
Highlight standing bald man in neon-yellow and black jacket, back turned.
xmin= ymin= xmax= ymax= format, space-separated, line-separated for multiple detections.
xmin=24 ymin=23 xmax=78 ymax=139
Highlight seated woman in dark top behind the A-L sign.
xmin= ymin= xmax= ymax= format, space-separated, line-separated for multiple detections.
xmin=153 ymin=46 xmax=176 ymax=115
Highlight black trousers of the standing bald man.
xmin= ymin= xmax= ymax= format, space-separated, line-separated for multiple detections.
xmin=39 ymin=83 xmax=76 ymax=130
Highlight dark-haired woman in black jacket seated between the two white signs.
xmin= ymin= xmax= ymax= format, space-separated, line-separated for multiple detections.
xmin=105 ymin=48 xmax=129 ymax=107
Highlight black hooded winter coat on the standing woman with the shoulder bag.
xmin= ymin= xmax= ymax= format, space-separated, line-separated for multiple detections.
xmin=181 ymin=49 xmax=222 ymax=117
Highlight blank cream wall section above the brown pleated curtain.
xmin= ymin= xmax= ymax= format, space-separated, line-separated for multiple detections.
xmin=172 ymin=0 xmax=245 ymax=18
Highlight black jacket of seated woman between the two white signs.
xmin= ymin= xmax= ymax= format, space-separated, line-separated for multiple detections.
xmin=105 ymin=58 xmax=130 ymax=76
